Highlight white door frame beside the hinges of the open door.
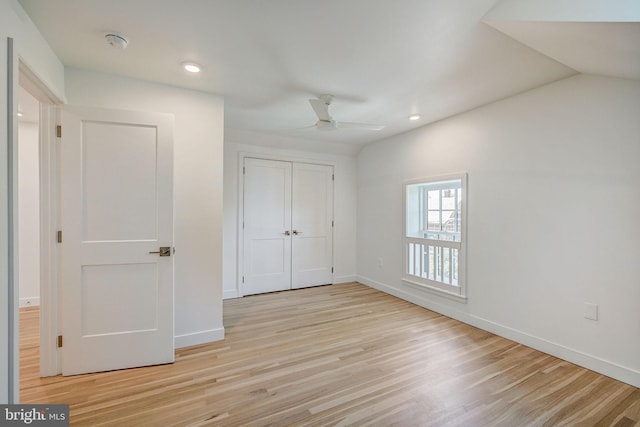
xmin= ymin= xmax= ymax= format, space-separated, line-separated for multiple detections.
xmin=18 ymin=60 xmax=63 ymax=377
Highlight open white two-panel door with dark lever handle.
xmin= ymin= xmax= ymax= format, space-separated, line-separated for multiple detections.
xmin=60 ymin=107 xmax=174 ymax=375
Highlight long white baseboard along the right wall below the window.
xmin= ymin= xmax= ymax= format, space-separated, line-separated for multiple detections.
xmin=357 ymin=276 xmax=640 ymax=387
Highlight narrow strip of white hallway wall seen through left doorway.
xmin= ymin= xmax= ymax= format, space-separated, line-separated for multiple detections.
xmin=18 ymin=122 xmax=40 ymax=307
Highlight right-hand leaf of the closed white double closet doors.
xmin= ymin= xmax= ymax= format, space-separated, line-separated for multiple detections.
xmin=291 ymin=163 xmax=333 ymax=288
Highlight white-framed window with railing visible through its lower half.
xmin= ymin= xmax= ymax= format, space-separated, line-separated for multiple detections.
xmin=403 ymin=174 xmax=467 ymax=300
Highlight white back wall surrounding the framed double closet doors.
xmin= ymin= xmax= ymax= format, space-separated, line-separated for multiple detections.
xmin=223 ymin=140 xmax=356 ymax=298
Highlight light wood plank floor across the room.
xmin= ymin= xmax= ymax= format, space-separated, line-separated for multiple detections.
xmin=21 ymin=283 xmax=640 ymax=427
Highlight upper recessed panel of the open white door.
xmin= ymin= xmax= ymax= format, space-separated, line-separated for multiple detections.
xmin=82 ymin=122 xmax=158 ymax=241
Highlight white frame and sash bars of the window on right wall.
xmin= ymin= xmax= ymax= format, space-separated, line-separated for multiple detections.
xmin=402 ymin=173 xmax=467 ymax=303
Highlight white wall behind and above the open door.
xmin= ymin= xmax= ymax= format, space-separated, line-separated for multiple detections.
xmin=65 ymin=69 xmax=224 ymax=347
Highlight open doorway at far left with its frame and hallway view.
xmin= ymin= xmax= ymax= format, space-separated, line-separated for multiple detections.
xmin=14 ymin=59 xmax=62 ymax=377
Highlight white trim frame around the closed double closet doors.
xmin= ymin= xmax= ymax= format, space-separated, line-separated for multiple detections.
xmin=236 ymin=151 xmax=336 ymax=297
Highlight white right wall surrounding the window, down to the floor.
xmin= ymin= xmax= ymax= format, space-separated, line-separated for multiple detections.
xmin=357 ymin=75 xmax=640 ymax=392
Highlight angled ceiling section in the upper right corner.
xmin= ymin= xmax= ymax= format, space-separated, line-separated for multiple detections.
xmin=483 ymin=0 xmax=640 ymax=80
